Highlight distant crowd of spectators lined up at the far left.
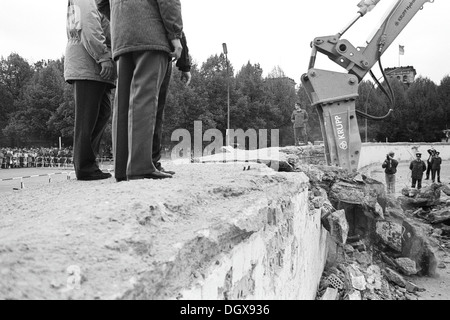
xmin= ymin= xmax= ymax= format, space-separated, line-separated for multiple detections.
xmin=0 ymin=147 xmax=112 ymax=169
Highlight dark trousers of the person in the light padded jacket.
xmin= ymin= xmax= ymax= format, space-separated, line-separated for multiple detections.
xmin=73 ymin=80 xmax=111 ymax=178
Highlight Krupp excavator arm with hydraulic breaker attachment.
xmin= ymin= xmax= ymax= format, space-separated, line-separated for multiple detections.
xmin=301 ymin=0 xmax=434 ymax=172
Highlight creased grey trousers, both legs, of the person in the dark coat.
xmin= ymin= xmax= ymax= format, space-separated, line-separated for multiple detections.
xmin=112 ymin=51 xmax=169 ymax=179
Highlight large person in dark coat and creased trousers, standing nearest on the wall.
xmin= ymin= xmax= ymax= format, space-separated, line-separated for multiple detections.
xmin=96 ymin=0 xmax=183 ymax=182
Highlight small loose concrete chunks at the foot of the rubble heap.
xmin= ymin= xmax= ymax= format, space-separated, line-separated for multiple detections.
xmin=317 ymin=240 xmax=424 ymax=300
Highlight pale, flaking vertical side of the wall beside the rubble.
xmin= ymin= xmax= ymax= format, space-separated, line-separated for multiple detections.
xmin=177 ymin=174 xmax=328 ymax=300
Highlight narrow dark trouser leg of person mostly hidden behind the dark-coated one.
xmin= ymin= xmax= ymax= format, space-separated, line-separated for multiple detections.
xmin=152 ymin=62 xmax=172 ymax=170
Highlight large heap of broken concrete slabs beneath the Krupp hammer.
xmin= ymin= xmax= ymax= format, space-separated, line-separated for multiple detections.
xmin=295 ymin=163 xmax=440 ymax=300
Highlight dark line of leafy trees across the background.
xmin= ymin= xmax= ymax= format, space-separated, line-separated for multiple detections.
xmin=0 ymin=53 xmax=450 ymax=148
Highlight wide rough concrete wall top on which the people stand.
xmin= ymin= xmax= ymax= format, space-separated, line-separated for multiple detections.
xmin=0 ymin=163 xmax=314 ymax=299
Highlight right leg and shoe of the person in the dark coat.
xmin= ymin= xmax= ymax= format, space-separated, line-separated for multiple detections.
xmin=126 ymin=51 xmax=170 ymax=179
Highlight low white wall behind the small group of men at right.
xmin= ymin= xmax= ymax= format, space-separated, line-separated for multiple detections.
xmin=358 ymin=142 xmax=450 ymax=169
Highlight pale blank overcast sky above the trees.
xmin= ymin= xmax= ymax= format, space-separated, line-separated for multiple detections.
xmin=0 ymin=0 xmax=450 ymax=84
